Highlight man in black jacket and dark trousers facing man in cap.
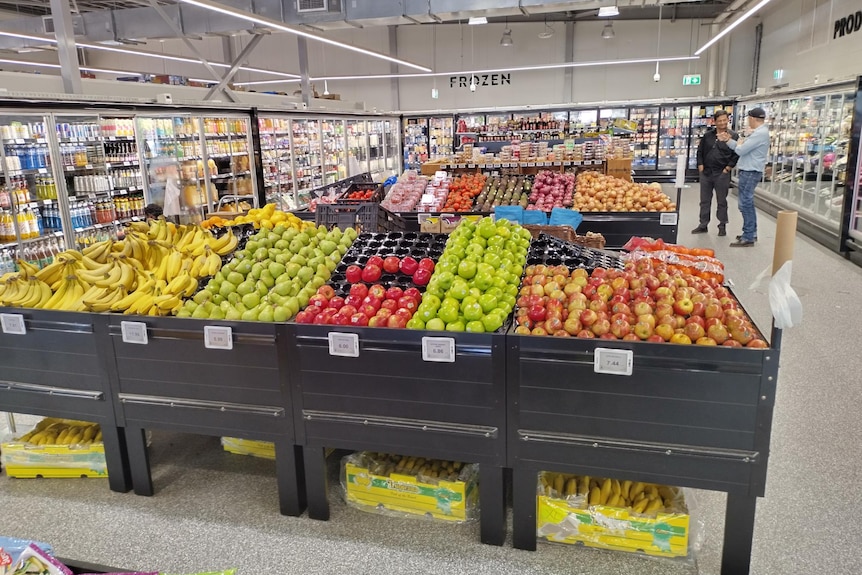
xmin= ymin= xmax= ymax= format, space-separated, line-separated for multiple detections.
xmin=691 ymin=110 xmax=739 ymax=236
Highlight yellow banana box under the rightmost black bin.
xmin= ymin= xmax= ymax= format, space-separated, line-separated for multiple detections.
xmin=536 ymin=472 xmax=693 ymax=557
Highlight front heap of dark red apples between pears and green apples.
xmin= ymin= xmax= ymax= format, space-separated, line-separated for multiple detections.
xmin=296 ymin=283 xmax=422 ymax=328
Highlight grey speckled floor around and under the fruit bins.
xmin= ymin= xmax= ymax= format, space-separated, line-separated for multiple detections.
xmin=0 ymin=188 xmax=862 ymax=575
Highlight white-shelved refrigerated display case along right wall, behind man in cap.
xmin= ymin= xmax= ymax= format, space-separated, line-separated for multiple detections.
xmin=737 ymin=83 xmax=856 ymax=249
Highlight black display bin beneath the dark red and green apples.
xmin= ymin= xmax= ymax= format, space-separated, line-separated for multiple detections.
xmin=288 ymin=324 xmax=506 ymax=545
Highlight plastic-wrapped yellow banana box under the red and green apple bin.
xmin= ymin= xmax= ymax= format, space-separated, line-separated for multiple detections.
xmin=341 ymin=452 xmax=479 ymax=523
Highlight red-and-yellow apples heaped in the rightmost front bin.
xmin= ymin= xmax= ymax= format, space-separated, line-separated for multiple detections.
xmin=515 ymin=259 xmax=769 ymax=348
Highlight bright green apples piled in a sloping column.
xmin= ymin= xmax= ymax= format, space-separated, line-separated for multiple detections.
xmin=414 ymin=218 xmax=531 ymax=333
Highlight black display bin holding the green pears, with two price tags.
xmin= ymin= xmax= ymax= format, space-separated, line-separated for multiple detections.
xmin=110 ymin=316 xmax=304 ymax=515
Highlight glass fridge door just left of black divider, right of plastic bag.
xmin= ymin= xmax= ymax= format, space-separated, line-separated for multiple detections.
xmin=203 ymin=116 xmax=257 ymax=211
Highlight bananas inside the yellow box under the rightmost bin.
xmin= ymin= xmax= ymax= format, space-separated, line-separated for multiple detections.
xmin=540 ymin=472 xmax=680 ymax=515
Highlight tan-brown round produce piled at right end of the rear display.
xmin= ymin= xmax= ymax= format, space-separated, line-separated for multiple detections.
xmin=573 ymin=171 xmax=676 ymax=216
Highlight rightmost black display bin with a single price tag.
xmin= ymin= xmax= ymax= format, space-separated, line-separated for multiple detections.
xmin=506 ymin=330 xmax=781 ymax=575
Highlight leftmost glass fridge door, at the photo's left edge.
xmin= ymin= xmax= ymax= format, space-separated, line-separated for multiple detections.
xmin=0 ymin=114 xmax=66 ymax=275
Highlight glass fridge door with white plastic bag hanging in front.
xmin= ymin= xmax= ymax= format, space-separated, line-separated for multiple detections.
xmin=136 ymin=114 xmax=208 ymax=225
